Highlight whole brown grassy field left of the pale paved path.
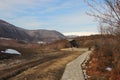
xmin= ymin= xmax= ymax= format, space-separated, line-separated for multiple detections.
xmin=0 ymin=37 xmax=85 ymax=80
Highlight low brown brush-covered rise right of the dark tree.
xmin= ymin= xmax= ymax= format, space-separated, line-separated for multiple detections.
xmin=75 ymin=34 xmax=115 ymax=47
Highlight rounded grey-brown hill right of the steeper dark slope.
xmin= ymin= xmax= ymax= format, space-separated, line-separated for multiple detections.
xmin=27 ymin=29 xmax=65 ymax=42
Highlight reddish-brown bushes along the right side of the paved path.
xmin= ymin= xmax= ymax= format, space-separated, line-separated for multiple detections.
xmin=86 ymin=39 xmax=120 ymax=80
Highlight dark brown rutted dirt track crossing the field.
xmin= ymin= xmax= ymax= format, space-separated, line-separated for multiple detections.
xmin=0 ymin=51 xmax=70 ymax=80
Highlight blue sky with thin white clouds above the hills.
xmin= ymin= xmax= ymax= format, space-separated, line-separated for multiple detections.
xmin=0 ymin=0 xmax=98 ymax=35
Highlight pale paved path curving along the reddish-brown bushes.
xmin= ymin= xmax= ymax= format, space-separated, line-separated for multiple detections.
xmin=61 ymin=51 xmax=91 ymax=80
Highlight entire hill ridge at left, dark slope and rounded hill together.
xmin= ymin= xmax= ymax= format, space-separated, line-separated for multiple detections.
xmin=0 ymin=20 xmax=65 ymax=42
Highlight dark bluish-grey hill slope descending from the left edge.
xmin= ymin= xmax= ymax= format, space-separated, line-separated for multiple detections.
xmin=0 ymin=20 xmax=30 ymax=40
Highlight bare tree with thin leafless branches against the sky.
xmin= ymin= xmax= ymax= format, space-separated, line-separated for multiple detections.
xmin=85 ymin=0 xmax=120 ymax=36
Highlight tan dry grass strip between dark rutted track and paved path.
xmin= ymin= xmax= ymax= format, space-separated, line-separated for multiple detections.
xmin=8 ymin=49 xmax=85 ymax=80
